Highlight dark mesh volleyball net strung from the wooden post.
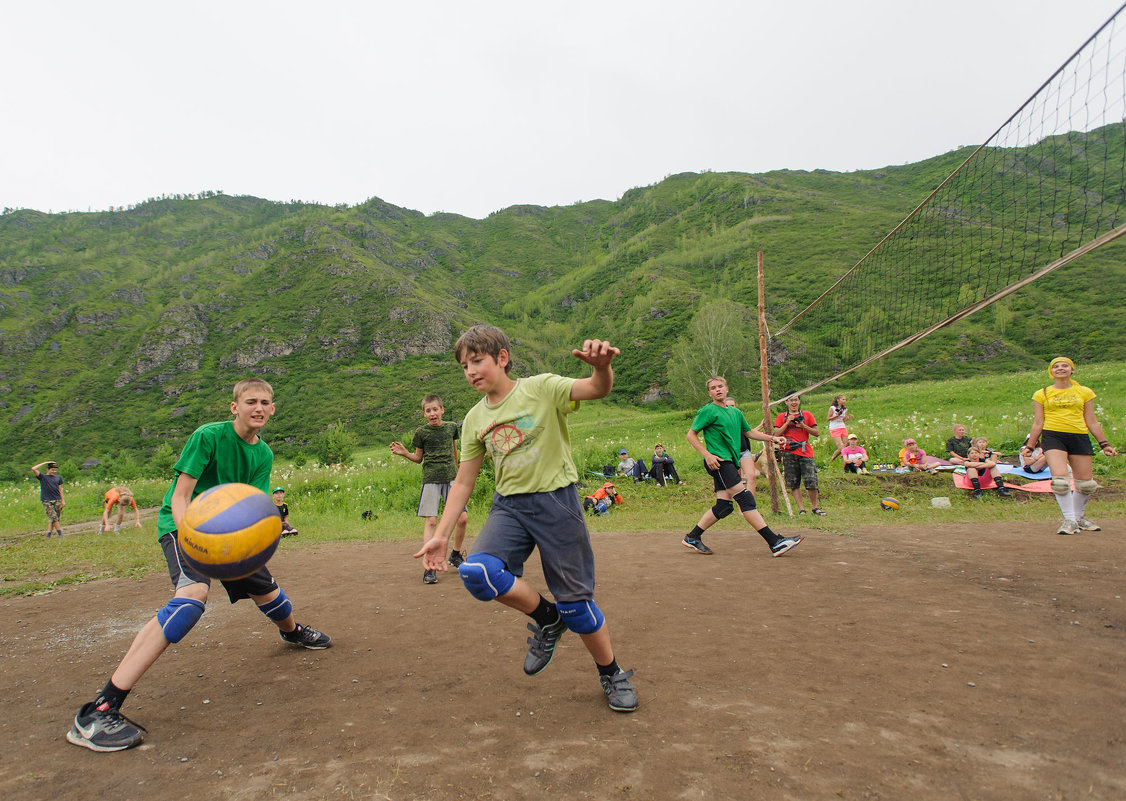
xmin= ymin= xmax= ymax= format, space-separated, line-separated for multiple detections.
xmin=768 ymin=5 xmax=1126 ymax=392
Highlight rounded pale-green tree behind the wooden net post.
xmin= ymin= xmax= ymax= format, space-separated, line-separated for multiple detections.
xmin=669 ymin=300 xmax=760 ymax=407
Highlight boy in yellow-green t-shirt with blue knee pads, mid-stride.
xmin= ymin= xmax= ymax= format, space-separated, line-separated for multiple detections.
xmin=414 ymin=326 xmax=637 ymax=712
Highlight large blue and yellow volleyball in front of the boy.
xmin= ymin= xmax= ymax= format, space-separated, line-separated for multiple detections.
xmin=178 ymin=483 xmax=282 ymax=579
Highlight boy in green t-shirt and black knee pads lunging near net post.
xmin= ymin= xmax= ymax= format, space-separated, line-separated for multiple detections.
xmin=683 ymin=375 xmax=803 ymax=557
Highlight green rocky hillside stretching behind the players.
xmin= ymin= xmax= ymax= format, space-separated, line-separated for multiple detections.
xmin=0 ymin=140 xmax=1126 ymax=465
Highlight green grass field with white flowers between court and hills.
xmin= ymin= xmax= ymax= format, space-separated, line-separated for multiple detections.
xmin=0 ymin=364 xmax=1126 ymax=596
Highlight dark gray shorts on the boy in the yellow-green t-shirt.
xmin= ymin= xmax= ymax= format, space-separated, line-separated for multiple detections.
xmin=473 ymin=484 xmax=595 ymax=603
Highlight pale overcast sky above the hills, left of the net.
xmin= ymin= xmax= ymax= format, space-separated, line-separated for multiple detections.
xmin=0 ymin=0 xmax=1119 ymax=217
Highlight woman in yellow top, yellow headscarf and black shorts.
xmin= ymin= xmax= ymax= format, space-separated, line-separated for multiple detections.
xmin=1020 ymin=356 xmax=1118 ymax=534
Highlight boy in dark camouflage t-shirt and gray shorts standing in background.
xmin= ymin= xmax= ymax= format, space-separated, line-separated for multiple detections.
xmin=391 ymin=395 xmax=470 ymax=584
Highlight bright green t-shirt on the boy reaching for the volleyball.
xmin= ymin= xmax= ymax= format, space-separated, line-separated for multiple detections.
xmin=157 ymin=420 xmax=274 ymax=536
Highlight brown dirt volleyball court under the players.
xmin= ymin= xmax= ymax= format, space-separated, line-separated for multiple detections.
xmin=0 ymin=520 xmax=1126 ymax=801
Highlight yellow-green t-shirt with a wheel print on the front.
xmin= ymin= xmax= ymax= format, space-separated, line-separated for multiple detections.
xmin=462 ymin=373 xmax=579 ymax=496
